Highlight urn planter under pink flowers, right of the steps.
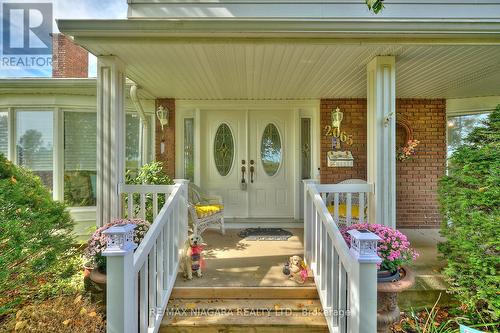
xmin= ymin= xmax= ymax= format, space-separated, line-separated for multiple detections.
xmin=377 ymin=267 xmax=415 ymax=333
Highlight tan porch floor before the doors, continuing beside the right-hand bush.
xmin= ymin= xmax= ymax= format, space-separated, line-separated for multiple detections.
xmin=175 ymin=228 xmax=450 ymax=307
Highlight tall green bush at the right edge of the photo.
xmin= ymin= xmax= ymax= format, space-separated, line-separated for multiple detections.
xmin=439 ymin=105 xmax=500 ymax=321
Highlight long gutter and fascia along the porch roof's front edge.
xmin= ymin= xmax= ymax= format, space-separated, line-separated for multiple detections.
xmin=57 ymin=18 xmax=500 ymax=41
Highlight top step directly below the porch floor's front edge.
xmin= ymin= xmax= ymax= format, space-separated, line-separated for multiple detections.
xmin=170 ymin=286 xmax=319 ymax=299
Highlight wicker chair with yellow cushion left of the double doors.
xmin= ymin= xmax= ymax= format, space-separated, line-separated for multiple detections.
xmin=188 ymin=183 xmax=226 ymax=235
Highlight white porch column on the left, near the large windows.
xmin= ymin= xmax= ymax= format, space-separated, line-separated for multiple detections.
xmin=97 ymin=56 xmax=125 ymax=226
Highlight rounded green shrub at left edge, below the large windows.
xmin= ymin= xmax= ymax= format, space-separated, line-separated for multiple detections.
xmin=0 ymin=154 xmax=73 ymax=317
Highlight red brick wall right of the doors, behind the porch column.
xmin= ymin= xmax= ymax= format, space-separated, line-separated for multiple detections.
xmin=320 ymin=99 xmax=446 ymax=228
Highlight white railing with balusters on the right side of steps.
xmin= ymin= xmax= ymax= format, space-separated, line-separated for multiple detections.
xmin=304 ymin=180 xmax=379 ymax=333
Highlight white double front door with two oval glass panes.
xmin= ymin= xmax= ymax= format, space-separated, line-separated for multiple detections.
xmin=200 ymin=109 xmax=294 ymax=218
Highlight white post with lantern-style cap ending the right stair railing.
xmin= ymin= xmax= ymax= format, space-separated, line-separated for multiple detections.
xmin=348 ymin=230 xmax=382 ymax=333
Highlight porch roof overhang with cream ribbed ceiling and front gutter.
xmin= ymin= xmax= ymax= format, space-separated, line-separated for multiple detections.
xmin=57 ymin=18 xmax=500 ymax=99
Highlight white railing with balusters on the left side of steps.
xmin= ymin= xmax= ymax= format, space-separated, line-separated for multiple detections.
xmin=105 ymin=180 xmax=188 ymax=333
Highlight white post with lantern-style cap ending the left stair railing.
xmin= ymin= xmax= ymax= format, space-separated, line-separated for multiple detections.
xmin=102 ymin=224 xmax=137 ymax=333
